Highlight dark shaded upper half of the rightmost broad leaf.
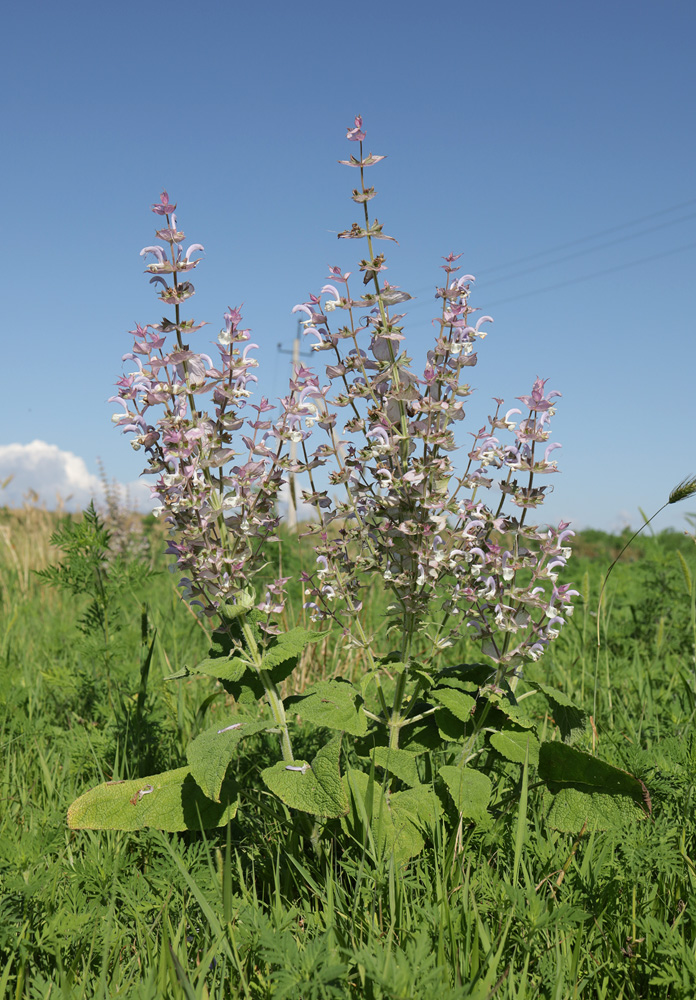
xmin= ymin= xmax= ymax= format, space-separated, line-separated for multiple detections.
xmin=539 ymin=742 xmax=647 ymax=804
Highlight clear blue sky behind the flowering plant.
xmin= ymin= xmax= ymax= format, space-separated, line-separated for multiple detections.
xmin=0 ymin=0 xmax=696 ymax=530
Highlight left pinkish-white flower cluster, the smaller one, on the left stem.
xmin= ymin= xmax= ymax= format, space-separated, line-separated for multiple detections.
xmin=111 ymin=191 xmax=286 ymax=631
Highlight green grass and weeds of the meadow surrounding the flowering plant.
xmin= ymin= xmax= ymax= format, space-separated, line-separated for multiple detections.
xmin=0 ymin=511 xmax=696 ymax=1000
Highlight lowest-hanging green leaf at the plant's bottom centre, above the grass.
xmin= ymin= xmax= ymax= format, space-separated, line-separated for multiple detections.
xmin=341 ymin=769 xmax=425 ymax=864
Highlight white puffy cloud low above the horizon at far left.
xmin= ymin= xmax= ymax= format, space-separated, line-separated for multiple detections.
xmin=0 ymin=440 xmax=150 ymax=510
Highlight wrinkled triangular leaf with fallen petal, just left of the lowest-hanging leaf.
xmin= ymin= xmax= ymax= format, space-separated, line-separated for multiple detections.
xmin=261 ymin=736 xmax=348 ymax=817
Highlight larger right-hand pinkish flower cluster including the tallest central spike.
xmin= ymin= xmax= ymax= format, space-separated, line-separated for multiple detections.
xmin=283 ymin=117 xmax=576 ymax=676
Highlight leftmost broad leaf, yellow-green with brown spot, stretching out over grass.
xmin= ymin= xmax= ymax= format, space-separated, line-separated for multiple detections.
xmin=68 ymin=767 xmax=239 ymax=833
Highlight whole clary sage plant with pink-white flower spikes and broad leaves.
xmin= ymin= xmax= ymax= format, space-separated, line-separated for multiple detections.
xmin=69 ymin=117 xmax=643 ymax=858
